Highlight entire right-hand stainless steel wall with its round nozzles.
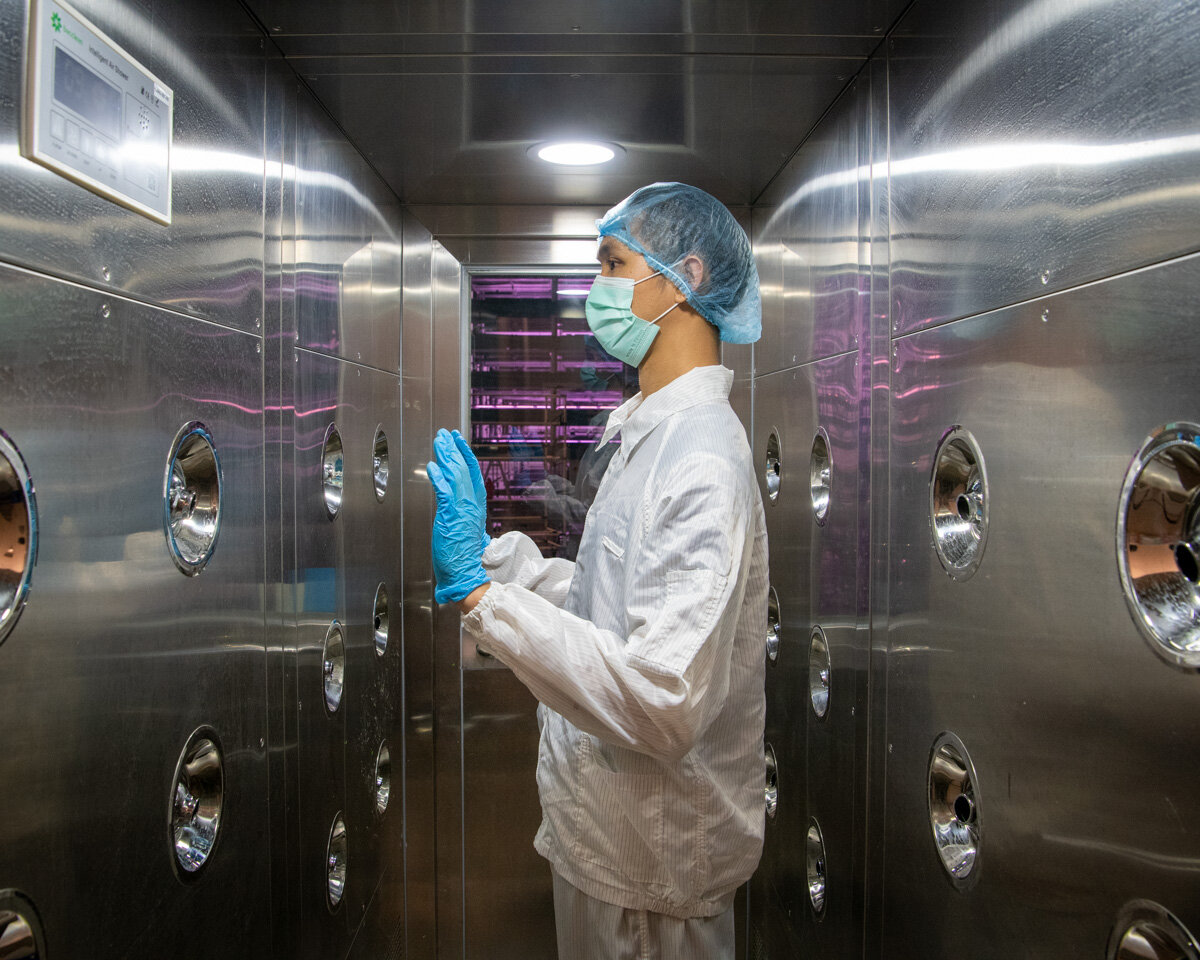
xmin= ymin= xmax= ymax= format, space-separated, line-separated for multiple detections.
xmin=750 ymin=0 xmax=1200 ymax=960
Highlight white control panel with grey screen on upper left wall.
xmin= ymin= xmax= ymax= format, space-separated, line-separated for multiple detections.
xmin=22 ymin=0 xmax=174 ymax=223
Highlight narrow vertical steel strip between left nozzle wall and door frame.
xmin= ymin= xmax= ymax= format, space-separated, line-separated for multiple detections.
xmin=397 ymin=214 xmax=437 ymax=956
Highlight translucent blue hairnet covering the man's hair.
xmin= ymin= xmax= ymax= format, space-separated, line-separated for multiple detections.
xmin=596 ymin=184 xmax=762 ymax=343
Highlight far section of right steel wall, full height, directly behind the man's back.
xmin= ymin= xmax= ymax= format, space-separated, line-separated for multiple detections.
xmin=744 ymin=74 xmax=871 ymax=958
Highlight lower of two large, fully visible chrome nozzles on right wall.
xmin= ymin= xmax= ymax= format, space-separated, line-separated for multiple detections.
xmin=929 ymin=733 xmax=979 ymax=889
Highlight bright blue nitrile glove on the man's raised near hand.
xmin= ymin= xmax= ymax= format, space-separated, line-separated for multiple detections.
xmin=425 ymin=430 xmax=491 ymax=604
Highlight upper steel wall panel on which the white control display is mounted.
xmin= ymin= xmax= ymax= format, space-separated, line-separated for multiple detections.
xmin=0 ymin=0 xmax=264 ymax=331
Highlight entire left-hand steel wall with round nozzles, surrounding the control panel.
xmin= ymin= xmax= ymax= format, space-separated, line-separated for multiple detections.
xmin=0 ymin=0 xmax=432 ymax=958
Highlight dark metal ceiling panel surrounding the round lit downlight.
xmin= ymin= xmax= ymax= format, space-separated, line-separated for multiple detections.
xmin=298 ymin=64 xmax=862 ymax=207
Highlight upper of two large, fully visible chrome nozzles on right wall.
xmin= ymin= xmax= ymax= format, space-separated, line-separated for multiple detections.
xmin=929 ymin=426 xmax=988 ymax=580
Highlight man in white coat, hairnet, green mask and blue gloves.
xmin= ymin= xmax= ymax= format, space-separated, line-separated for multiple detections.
xmin=428 ymin=184 xmax=768 ymax=960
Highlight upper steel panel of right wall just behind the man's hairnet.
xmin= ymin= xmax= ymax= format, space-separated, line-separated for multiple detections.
xmin=755 ymin=78 xmax=868 ymax=376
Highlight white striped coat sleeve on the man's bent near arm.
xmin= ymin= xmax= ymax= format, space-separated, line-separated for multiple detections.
xmin=464 ymin=454 xmax=752 ymax=762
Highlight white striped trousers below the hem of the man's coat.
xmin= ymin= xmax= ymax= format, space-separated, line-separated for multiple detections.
xmin=551 ymin=871 xmax=733 ymax=960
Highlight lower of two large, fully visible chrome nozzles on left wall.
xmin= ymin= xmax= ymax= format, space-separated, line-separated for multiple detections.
xmin=170 ymin=727 xmax=224 ymax=878
